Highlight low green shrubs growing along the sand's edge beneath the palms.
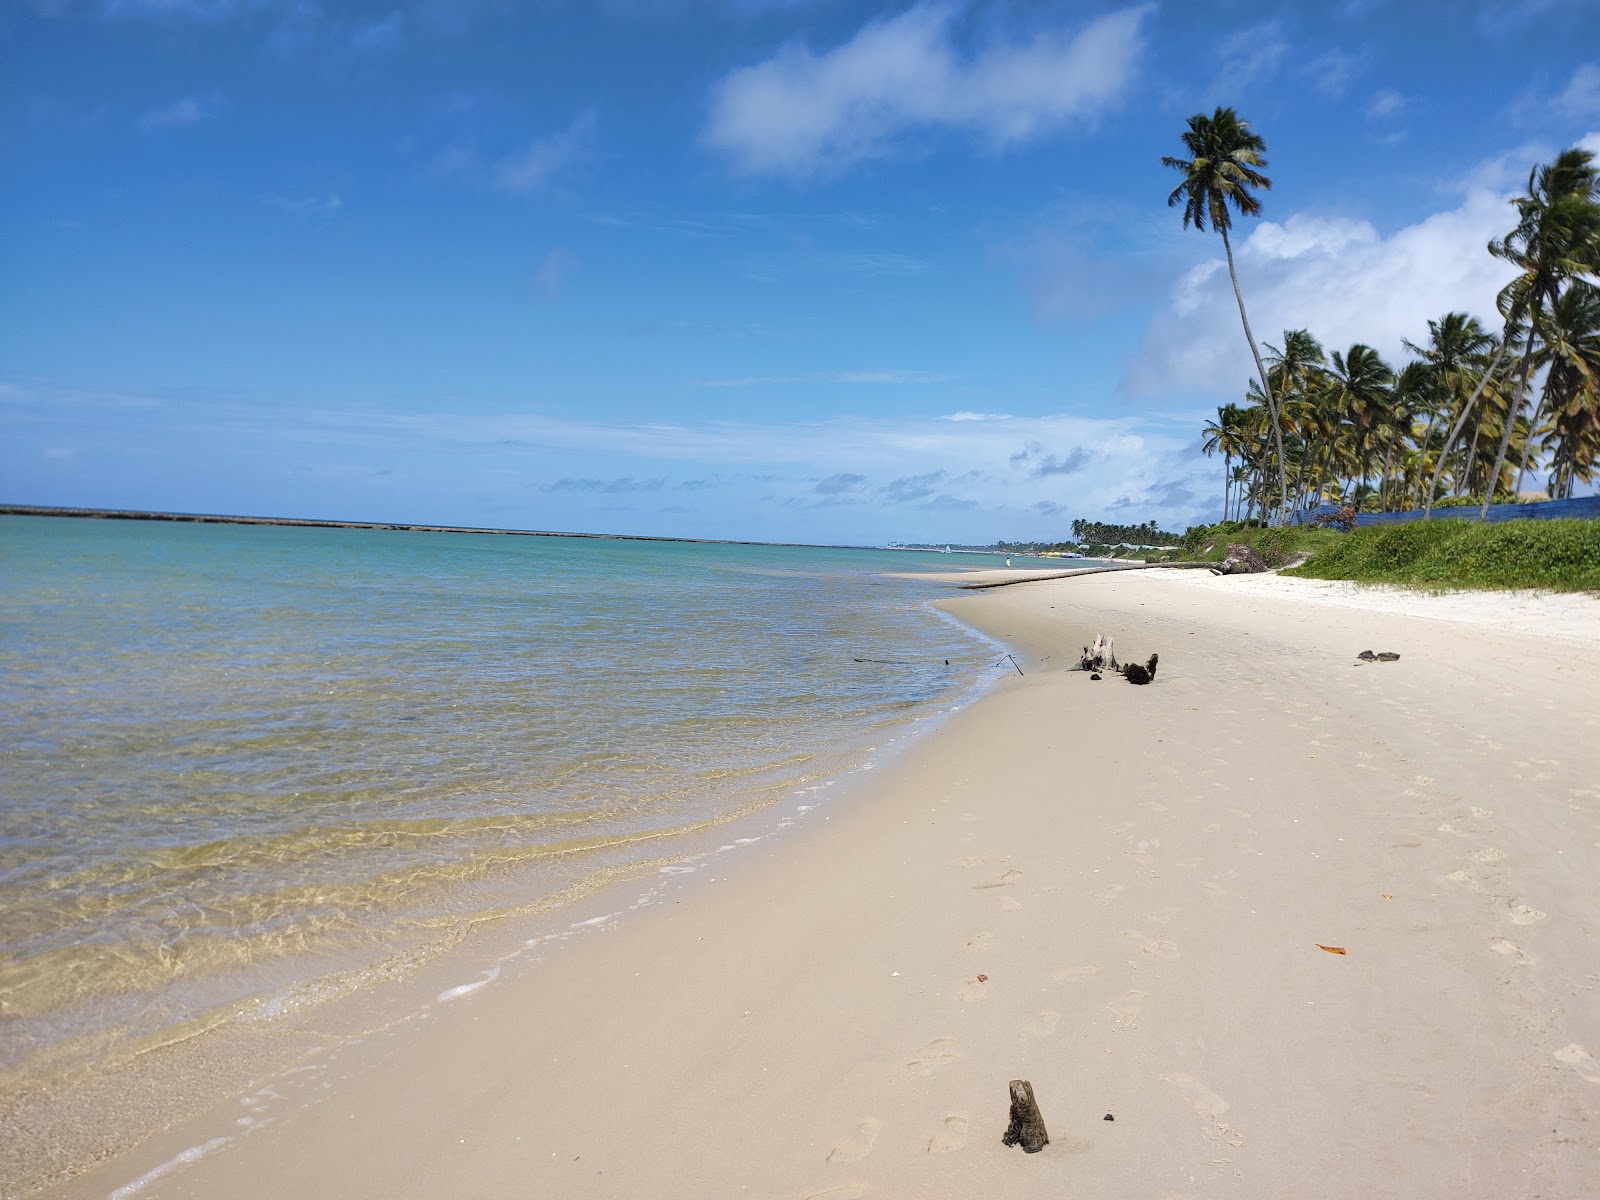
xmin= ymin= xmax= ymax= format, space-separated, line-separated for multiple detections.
xmin=1286 ymin=518 xmax=1600 ymax=592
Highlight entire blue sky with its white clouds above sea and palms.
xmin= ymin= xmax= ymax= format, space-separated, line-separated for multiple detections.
xmin=0 ymin=0 xmax=1600 ymax=542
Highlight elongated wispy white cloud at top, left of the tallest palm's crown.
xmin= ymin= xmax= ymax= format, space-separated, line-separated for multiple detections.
xmin=706 ymin=0 xmax=1152 ymax=178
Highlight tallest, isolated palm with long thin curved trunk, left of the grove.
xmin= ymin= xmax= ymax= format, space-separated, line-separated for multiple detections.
xmin=1162 ymin=107 xmax=1290 ymax=523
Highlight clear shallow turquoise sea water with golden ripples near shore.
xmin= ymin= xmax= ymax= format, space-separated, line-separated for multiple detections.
xmin=0 ymin=517 xmax=1017 ymax=1072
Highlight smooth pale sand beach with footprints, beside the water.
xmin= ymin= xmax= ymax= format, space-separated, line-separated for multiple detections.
xmin=28 ymin=571 xmax=1600 ymax=1200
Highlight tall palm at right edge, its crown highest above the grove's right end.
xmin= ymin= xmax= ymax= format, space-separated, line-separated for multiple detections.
xmin=1478 ymin=147 xmax=1600 ymax=520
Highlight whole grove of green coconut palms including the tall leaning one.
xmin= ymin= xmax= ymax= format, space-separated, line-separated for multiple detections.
xmin=1162 ymin=109 xmax=1600 ymax=523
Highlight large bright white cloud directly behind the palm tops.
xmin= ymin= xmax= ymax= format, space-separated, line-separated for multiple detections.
xmin=1125 ymin=187 xmax=1515 ymax=398
